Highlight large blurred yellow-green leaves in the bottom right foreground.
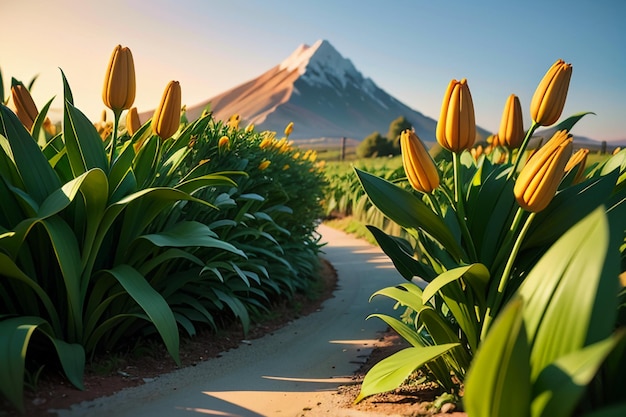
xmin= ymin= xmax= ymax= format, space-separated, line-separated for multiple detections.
xmin=464 ymin=208 xmax=626 ymax=417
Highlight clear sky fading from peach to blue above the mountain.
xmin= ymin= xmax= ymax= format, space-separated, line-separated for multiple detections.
xmin=0 ymin=0 xmax=626 ymax=141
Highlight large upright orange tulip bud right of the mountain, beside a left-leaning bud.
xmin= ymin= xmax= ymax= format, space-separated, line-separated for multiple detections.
xmin=437 ymin=78 xmax=476 ymax=153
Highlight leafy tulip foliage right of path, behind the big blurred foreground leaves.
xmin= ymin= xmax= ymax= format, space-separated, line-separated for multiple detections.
xmin=346 ymin=109 xmax=626 ymax=402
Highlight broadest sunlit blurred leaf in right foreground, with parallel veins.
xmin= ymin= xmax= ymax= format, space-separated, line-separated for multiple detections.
xmin=519 ymin=207 xmax=623 ymax=378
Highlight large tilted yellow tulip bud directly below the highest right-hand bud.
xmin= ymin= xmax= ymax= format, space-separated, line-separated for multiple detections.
xmin=513 ymin=130 xmax=572 ymax=213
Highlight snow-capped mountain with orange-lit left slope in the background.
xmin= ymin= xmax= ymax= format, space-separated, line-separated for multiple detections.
xmin=187 ymin=40 xmax=489 ymax=142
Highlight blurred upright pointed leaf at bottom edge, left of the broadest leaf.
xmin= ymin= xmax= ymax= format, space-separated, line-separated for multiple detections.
xmin=463 ymin=299 xmax=531 ymax=417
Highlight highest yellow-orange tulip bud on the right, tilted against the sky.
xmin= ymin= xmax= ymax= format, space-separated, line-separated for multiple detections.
xmin=530 ymin=59 xmax=572 ymax=126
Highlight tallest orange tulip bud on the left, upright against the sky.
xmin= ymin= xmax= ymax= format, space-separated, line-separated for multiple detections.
xmin=102 ymin=45 xmax=136 ymax=114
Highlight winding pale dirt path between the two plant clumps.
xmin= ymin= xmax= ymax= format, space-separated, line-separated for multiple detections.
xmin=51 ymin=226 xmax=401 ymax=417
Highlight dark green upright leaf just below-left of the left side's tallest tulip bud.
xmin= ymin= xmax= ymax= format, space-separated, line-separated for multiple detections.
xmin=63 ymin=100 xmax=109 ymax=176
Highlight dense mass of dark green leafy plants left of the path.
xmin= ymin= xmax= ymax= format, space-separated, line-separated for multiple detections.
xmin=0 ymin=75 xmax=325 ymax=409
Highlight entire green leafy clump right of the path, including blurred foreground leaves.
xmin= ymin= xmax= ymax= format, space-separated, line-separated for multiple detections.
xmin=329 ymin=78 xmax=626 ymax=416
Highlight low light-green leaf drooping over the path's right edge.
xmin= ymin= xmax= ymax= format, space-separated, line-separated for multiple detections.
xmin=354 ymin=343 xmax=458 ymax=403
